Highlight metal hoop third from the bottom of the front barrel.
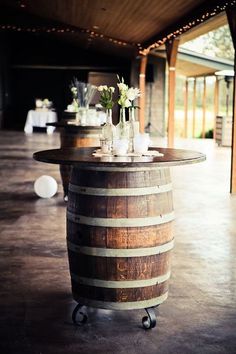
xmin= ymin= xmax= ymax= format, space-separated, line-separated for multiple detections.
xmin=67 ymin=240 xmax=174 ymax=257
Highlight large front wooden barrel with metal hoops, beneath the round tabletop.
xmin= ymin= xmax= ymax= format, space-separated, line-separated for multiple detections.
xmin=67 ymin=167 xmax=174 ymax=310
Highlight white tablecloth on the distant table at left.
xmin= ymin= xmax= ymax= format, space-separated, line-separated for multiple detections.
xmin=24 ymin=110 xmax=57 ymax=134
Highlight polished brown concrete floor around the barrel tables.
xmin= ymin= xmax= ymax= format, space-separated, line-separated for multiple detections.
xmin=0 ymin=131 xmax=236 ymax=354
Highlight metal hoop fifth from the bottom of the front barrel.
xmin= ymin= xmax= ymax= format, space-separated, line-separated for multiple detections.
xmin=69 ymin=183 xmax=172 ymax=197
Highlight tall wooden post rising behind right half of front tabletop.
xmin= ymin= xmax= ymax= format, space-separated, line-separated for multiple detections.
xmin=166 ymin=38 xmax=179 ymax=147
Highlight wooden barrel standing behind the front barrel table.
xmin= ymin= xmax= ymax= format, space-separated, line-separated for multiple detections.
xmin=60 ymin=125 xmax=102 ymax=195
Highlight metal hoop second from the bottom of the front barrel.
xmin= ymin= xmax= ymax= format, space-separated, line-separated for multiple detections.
xmin=70 ymin=272 xmax=170 ymax=289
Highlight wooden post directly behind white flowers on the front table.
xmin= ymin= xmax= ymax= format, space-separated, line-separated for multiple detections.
xmin=139 ymin=55 xmax=147 ymax=133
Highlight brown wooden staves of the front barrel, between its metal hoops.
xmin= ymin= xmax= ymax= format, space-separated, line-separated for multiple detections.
xmin=67 ymin=166 xmax=173 ymax=308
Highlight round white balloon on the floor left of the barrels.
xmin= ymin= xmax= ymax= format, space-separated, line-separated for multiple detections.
xmin=34 ymin=175 xmax=57 ymax=198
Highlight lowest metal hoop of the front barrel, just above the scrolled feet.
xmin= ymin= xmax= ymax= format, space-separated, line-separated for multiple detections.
xmin=73 ymin=291 xmax=168 ymax=310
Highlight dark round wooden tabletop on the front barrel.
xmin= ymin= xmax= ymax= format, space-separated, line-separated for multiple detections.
xmin=33 ymin=147 xmax=206 ymax=169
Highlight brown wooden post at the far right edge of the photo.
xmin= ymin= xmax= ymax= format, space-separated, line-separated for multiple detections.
xmin=226 ymin=7 xmax=236 ymax=193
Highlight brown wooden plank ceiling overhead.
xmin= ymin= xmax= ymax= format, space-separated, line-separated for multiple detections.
xmin=0 ymin=0 xmax=231 ymax=54
